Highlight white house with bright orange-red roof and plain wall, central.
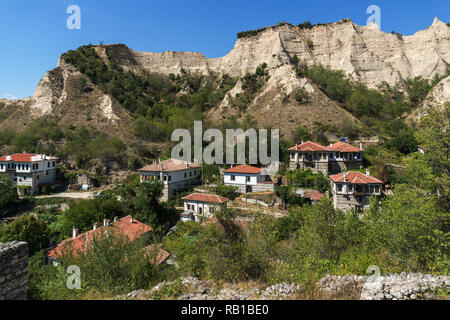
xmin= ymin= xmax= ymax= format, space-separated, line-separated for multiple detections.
xmin=223 ymin=164 xmax=274 ymax=193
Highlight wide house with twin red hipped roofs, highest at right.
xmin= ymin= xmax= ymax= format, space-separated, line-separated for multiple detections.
xmin=289 ymin=141 xmax=363 ymax=175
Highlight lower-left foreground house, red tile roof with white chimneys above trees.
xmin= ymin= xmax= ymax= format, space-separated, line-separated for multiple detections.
xmin=45 ymin=216 xmax=152 ymax=264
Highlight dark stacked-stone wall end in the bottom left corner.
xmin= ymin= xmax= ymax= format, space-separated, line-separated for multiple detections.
xmin=0 ymin=241 xmax=28 ymax=300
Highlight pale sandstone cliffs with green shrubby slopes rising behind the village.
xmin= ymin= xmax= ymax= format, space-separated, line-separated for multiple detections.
xmin=0 ymin=19 xmax=450 ymax=172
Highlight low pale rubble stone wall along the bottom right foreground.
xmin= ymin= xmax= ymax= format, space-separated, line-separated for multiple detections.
xmin=117 ymin=273 xmax=450 ymax=300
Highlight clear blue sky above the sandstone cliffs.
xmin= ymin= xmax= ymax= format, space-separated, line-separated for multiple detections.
xmin=0 ymin=0 xmax=450 ymax=98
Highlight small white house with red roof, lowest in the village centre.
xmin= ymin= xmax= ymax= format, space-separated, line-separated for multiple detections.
xmin=181 ymin=193 xmax=228 ymax=222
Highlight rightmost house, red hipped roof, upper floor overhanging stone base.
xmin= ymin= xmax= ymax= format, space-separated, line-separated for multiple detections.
xmin=330 ymin=170 xmax=383 ymax=212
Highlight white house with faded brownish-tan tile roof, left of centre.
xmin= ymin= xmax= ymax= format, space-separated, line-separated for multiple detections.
xmin=139 ymin=159 xmax=202 ymax=201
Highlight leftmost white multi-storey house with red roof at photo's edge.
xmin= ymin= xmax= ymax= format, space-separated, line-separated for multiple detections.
xmin=0 ymin=152 xmax=58 ymax=194
